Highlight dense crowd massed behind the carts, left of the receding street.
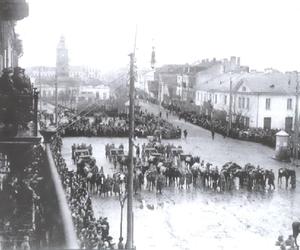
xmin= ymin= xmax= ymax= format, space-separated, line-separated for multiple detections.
xmin=61 ymin=111 xmax=181 ymax=139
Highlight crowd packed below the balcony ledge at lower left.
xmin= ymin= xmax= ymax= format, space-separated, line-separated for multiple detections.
xmin=51 ymin=136 xmax=114 ymax=249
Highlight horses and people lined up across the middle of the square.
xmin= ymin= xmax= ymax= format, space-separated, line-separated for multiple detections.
xmin=77 ymin=135 xmax=296 ymax=201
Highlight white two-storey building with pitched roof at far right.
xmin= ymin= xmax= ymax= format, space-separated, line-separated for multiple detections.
xmin=195 ymin=71 xmax=296 ymax=131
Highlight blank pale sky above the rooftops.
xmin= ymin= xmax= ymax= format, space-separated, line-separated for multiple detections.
xmin=16 ymin=0 xmax=300 ymax=71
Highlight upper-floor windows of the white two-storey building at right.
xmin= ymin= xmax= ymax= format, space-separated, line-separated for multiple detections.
xmin=197 ymin=92 xmax=293 ymax=110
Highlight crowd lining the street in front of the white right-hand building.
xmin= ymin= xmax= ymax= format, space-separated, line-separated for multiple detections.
xmin=163 ymin=104 xmax=279 ymax=147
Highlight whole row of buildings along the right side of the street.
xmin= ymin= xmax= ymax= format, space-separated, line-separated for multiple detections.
xmin=137 ymin=57 xmax=296 ymax=131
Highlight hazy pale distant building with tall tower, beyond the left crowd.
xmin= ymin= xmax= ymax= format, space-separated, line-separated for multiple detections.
xmin=28 ymin=37 xmax=110 ymax=105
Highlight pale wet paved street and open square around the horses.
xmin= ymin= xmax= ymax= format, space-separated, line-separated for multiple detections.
xmin=63 ymin=104 xmax=300 ymax=250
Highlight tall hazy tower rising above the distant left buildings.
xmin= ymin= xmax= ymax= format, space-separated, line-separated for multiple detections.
xmin=56 ymin=36 xmax=69 ymax=77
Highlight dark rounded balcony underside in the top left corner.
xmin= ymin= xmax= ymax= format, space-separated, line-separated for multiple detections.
xmin=0 ymin=0 xmax=29 ymax=21
